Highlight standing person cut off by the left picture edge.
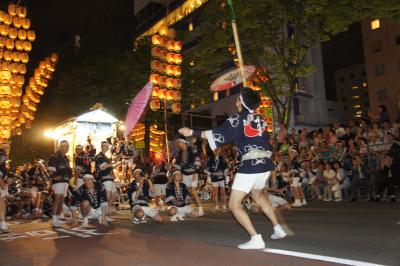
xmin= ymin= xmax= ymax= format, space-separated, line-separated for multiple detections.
xmin=0 ymin=149 xmax=10 ymax=234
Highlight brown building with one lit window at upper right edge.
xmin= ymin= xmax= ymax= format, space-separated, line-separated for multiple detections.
xmin=362 ymin=18 xmax=400 ymax=120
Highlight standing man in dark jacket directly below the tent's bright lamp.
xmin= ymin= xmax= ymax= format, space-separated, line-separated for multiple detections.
xmin=47 ymin=140 xmax=72 ymax=226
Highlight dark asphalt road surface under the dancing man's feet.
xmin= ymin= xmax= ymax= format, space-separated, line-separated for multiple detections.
xmin=0 ymin=202 xmax=400 ymax=266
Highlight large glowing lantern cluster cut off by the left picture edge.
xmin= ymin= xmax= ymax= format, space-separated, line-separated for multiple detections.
xmin=0 ymin=4 xmax=36 ymax=144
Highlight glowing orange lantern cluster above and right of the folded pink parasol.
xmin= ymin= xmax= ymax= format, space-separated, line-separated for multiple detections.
xmin=150 ymin=27 xmax=183 ymax=113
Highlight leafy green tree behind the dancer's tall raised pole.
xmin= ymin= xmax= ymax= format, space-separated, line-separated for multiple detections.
xmin=180 ymin=0 xmax=400 ymax=124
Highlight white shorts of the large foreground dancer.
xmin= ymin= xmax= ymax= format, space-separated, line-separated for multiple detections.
xmin=232 ymin=171 xmax=271 ymax=193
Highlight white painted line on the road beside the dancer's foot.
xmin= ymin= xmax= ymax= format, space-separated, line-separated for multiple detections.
xmin=263 ymin=248 xmax=383 ymax=266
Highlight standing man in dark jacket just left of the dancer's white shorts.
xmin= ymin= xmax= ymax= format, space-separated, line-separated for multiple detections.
xmin=206 ymin=148 xmax=228 ymax=212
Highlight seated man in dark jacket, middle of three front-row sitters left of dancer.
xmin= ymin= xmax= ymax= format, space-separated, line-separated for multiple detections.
xmin=128 ymin=168 xmax=162 ymax=224
